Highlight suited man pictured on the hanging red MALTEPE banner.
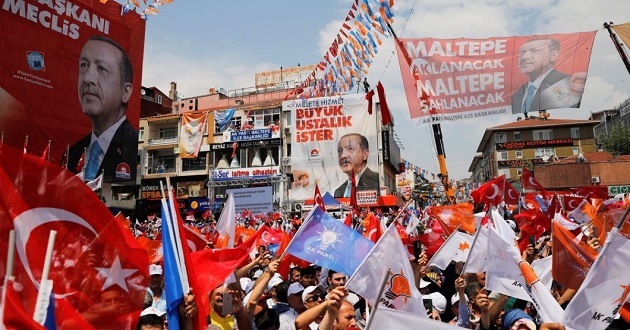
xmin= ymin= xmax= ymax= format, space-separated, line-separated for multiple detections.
xmin=512 ymin=38 xmax=586 ymax=114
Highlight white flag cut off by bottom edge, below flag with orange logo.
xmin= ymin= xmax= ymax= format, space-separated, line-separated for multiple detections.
xmin=369 ymin=307 xmax=462 ymax=330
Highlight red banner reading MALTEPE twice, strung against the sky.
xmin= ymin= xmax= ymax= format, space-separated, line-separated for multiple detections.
xmin=396 ymin=31 xmax=595 ymax=126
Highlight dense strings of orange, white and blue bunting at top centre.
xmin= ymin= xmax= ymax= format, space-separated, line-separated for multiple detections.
xmin=286 ymin=0 xmax=394 ymax=98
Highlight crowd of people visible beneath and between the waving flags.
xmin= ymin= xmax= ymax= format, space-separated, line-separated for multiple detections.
xmin=133 ymin=193 xmax=630 ymax=330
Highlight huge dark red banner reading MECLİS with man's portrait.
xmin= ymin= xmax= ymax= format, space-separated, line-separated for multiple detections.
xmin=0 ymin=0 xmax=146 ymax=181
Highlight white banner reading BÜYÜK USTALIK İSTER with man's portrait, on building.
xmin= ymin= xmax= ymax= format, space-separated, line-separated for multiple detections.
xmin=282 ymin=94 xmax=380 ymax=200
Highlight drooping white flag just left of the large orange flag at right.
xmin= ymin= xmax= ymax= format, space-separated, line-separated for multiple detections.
xmin=486 ymin=228 xmax=532 ymax=301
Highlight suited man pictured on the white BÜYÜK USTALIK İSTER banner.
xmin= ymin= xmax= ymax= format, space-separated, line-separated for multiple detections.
xmin=335 ymin=133 xmax=380 ymax=197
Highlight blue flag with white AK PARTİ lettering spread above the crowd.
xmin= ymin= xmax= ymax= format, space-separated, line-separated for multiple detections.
xmin=286 ymin=207 xmax=374 ymax=276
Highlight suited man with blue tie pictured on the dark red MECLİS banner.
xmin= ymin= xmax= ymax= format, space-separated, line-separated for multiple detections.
xmin=68 ymin=36 xmax=138 ymax=182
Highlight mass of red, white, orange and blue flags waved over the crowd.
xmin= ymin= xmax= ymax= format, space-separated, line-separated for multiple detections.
xmin=0 ymin=136 xmax=630 ymax=329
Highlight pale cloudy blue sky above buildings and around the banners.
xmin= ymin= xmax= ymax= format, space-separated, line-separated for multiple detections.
xmin=142 ymin=0 xmax=630 ymax=180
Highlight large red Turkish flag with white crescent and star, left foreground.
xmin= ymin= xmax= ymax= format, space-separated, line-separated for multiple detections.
xmin=0 ymin=145 xmax=149 ymax=329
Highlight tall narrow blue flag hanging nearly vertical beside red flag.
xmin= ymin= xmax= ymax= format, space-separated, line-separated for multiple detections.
xmin=162 ymin=203 xmax=184 ymax=330
